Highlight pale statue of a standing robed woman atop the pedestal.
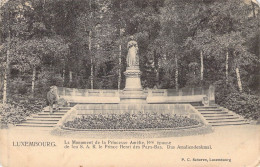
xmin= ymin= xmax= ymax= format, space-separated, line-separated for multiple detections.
xmin=126 ymin=36 xmax=139 ymax=67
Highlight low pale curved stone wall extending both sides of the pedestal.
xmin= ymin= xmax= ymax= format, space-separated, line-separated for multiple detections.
xmin=58 ymin=86 xmax=215 ymax=104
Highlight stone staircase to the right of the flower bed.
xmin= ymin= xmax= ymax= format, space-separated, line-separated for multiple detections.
xmin=194 ymin=105 xmax=249 ymax=126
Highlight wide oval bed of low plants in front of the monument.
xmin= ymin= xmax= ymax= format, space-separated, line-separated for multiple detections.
xmin=64 ymin=112 xmax=200 ymax=130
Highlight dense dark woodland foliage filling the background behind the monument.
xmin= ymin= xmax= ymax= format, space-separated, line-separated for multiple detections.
xmin=0 ymin=0 xmax=260 ymax=121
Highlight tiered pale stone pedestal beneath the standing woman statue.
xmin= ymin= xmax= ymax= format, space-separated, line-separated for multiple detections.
xmin=120 ymin=66 xmax=146 ymax=103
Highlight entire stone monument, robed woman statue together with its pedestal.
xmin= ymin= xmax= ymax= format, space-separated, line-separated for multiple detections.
xmin=120 ymin=36 xmax=146 ymax=103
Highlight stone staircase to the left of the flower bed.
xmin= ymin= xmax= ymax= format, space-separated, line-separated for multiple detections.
xmin=16 ymin=107 xmax=71 ymax=128
